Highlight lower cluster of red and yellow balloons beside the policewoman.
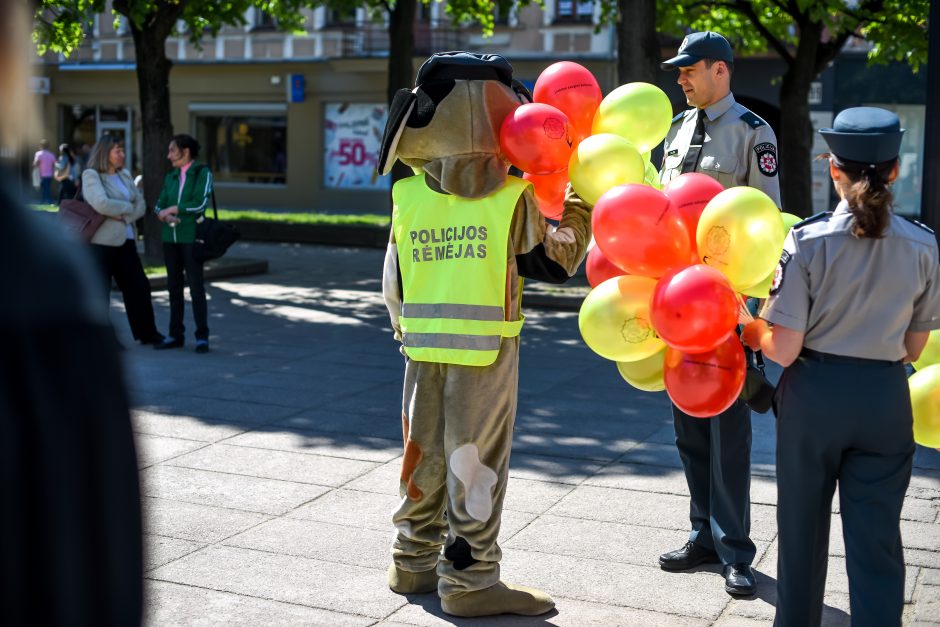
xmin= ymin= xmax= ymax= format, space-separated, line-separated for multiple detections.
xmin=572 ymin=172 xmax=784 ymax=418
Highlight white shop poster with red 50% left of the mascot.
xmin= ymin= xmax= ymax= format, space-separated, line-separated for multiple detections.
xmin=323 ymin=103 xmax=390 ymax=189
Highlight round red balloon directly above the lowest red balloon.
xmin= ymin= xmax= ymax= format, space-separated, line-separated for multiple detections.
xmin=650 ymin=264 xmax=740 ymax=353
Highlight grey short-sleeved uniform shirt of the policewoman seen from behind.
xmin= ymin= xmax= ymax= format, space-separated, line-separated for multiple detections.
xmin=761 ymin=201 xmax=940 ymax=361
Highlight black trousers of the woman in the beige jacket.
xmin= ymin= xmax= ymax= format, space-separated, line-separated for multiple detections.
xmin=91 ymin=239 xmax=159 ymax=342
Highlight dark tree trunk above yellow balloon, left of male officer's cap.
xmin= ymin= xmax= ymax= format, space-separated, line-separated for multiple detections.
xmin=617 ymin=0 xmax=661 ymax=85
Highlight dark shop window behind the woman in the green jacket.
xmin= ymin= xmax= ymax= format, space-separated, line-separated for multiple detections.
xmin=194 ymin=111 xmax=287 ymax=185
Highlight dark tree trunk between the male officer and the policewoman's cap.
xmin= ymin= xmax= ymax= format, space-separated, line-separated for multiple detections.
xmin=777 ymin=22 xmax=822 ymax=216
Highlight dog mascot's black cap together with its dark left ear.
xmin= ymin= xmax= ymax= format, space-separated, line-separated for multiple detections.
xmin=376 ymin=51 xmax=532 ymax=174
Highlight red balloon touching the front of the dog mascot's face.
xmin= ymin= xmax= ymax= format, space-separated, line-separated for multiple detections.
xmin=499 ymin=102 xmax=573 ymax=174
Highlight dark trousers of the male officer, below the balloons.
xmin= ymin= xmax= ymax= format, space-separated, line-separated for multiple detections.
xmin=672 ymin=399 xmax=756 ymax=564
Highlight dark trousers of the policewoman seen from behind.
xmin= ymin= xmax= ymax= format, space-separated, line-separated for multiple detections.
xmin=774 ymin=356 xmax=914 ymax=627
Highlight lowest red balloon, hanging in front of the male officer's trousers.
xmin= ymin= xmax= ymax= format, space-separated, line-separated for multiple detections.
xmin=663 ymin=336 xmax=745 ymax=418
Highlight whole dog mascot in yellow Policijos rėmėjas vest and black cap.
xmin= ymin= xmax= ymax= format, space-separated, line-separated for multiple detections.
xmin=378 ymin=52 xmax=591 ymax=616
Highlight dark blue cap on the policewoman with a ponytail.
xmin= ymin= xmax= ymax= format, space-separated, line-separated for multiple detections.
xmin=819 ymin=107 xmax=905 ymax=164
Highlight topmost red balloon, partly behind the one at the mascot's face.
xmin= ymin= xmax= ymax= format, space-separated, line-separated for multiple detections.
xmin=532 ymin=61 xmax=604 ymax=143
